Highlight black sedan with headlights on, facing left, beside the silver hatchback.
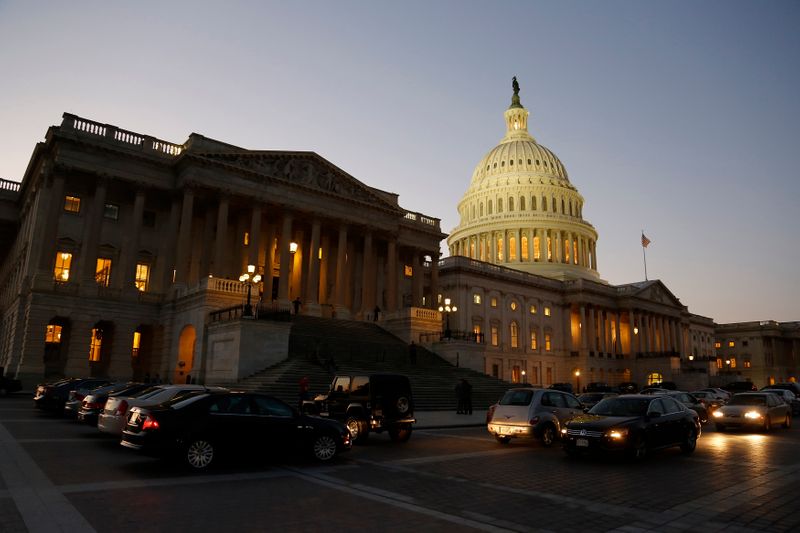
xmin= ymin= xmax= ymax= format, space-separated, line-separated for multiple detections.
xmin=561 ymin=394 xmax=700 ymax=459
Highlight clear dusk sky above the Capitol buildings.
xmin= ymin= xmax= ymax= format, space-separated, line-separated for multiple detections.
xmin=0 ymin=0 xmax=800 ymax=323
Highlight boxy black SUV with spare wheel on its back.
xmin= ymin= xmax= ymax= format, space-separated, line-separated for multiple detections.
xmin=314 ymin=374 xmax=416 ymax=442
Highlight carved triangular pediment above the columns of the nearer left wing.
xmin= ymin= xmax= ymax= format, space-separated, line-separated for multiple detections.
xmin=195 ymin=151 xmax=400 ymax=211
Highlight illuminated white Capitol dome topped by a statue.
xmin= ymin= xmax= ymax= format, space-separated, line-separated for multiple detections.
xmin=447 ymin=78 xmax=599 ymax=280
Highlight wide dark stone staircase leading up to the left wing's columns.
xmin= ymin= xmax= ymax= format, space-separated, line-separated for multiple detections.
xmin=236 ymin=316 xmax=513 ymax=410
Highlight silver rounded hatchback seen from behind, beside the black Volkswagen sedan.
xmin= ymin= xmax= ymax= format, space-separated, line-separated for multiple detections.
xmin=487 ymin=387 xmax=583 ymax=446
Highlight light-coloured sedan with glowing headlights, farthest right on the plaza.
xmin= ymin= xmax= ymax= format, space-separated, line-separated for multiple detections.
xmin=714 ymin=392 xmax=792 ymax=431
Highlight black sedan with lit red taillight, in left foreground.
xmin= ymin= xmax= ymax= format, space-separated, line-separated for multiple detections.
xmin=121 ymin=391 xmax=352 ymax=470
